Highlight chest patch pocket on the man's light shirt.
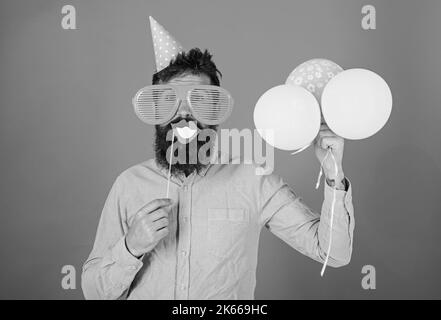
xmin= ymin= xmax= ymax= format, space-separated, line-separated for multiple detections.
xmin=207 ymin=208 xmax=249 ymax=258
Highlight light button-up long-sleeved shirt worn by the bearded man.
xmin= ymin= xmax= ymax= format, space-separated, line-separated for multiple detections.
xmin=82 ymin=159 xmax=354 ymax=300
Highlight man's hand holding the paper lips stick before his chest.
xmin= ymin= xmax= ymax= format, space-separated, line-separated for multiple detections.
xmin=126 ymin=199 xmax=173 ymax=257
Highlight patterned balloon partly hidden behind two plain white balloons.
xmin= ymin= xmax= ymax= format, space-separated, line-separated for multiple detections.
xmin=286 ymin=59 xmax=343 ymax=103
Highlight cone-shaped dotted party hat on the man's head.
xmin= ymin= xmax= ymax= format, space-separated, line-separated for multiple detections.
xmin=149 ymin=17 xmax=184 ymax=72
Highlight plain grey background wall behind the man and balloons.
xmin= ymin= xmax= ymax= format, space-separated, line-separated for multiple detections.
xmin=0 ymin=0 xmax=441 ymax=299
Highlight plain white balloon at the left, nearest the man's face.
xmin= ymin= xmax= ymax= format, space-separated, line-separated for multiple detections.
xmin=254 ymin=85 xmax=320 ymax=151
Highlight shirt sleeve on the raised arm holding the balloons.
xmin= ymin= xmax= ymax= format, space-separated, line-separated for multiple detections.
xmin=261 ymin=175 xmax=354 ymax=267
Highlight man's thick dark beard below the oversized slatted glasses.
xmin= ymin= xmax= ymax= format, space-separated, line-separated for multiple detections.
xmin=154 ymin=117 xmax=217 ymax=176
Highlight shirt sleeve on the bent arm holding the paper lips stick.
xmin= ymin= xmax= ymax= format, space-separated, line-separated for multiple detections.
xmin=81 ymin=175 xmax=143 ymax=299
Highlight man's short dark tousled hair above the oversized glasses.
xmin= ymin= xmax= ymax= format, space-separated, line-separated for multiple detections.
xmin=152 ymin=48 xmax=222 ymax=86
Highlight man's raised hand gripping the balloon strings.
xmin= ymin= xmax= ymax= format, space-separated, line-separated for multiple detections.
xmin=314 ymin=124 xmax=345 ymax=183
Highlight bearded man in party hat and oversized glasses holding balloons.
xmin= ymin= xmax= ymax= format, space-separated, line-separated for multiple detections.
xmin=82 ymin=19 xmax=354 ymax=299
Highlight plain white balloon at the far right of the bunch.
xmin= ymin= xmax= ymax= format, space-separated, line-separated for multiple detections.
xmin=321 ymin=69 xmax=392 ymax=140
